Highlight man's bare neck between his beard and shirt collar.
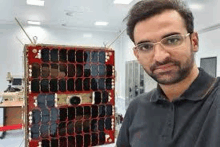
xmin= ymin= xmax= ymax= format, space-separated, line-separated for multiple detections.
xmin=159 ymin=65 xmax=199 ymax=102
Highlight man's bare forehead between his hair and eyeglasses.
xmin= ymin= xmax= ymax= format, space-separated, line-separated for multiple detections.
xmin=134 ymin=10 xmax=187 ymax=42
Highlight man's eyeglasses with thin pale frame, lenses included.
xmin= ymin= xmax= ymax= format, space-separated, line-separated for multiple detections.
xmin=134 ymin=33 xmax=190 ymax=53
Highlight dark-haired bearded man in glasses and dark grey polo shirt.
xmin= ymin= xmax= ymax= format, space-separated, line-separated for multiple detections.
xmin=117 ymin=0 xmax=220 ymax=147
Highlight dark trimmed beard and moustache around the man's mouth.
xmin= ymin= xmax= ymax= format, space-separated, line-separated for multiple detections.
xmin=144 ymin=48 xmax=195 ymax=85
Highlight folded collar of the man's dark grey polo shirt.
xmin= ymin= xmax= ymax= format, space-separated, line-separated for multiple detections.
xmin=150 ymin=68 xmax=216 ymax=102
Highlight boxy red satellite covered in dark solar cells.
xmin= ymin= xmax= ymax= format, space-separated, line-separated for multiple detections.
xmin=24 ymin=44 xmax=115 ymax=147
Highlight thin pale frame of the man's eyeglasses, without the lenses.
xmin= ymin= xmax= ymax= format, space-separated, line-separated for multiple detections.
xmin=133 ymin=33 xmax=191 ymax=52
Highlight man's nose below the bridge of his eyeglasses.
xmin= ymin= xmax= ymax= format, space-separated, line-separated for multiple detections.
xmin=154 ymin=43 xmax=170 ymax=63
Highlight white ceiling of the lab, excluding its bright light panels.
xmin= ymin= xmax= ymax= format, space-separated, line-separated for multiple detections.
xmin=0 ymin=0 xmax=220 ymax=32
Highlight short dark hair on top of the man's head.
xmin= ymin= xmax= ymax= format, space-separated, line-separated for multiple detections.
xmin=125 ymin=0 xmax=194 ymax=42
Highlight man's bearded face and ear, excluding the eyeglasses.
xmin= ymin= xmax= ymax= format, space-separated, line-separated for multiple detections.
xmin=134 ymin=10 xmax=198 ymax=85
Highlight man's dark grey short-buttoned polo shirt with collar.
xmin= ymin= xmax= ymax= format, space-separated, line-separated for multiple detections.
xmin=117 ymin=69 xmax=220 ymax=147
